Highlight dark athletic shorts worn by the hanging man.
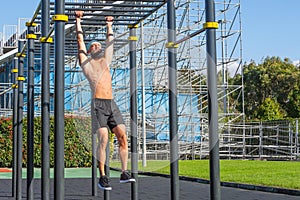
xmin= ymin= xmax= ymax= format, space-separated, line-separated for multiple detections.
xmin=92 ymin=99 xmax=124 ymax=133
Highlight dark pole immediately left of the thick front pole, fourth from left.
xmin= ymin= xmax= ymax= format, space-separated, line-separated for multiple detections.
xmin=41 ymin=0 xmax=50 ymax=200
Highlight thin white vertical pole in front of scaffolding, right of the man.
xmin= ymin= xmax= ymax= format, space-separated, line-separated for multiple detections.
xmin=140 ymin=22 xmax=147 ymax=167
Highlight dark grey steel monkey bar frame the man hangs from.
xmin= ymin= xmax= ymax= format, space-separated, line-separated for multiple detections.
xmin=0 ymin=0 xmax=225 ymax=199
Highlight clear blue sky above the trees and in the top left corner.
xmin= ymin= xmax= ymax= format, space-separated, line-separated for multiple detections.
xmin=0 ymin=0 xmax=300 ymax=63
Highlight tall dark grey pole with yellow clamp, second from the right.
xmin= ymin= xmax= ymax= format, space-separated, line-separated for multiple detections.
xmin=167 ymin=0 xmax=179 ymax=200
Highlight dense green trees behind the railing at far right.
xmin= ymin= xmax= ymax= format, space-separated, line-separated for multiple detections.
xmin=230 ymin=57 xmax=300 ymax=119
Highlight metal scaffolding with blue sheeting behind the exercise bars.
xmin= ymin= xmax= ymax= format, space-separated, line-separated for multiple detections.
xmin=0 ymin=0 xmax=243 ymax=152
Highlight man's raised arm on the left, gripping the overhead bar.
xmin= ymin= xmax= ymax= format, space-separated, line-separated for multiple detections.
xmin=75 ymin=11 xmax=87 ymax=65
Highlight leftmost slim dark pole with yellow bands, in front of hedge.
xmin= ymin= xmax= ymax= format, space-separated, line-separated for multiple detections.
xmin=12 ymin=57 xmax=18 ymax=197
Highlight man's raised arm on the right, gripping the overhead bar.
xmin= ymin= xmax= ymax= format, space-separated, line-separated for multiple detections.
xmin=104 ymin=16 xmax=114 ymax=65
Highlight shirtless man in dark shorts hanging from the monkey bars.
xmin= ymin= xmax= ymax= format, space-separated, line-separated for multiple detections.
xmin=75 ymin=11 xmax=135 ymax=190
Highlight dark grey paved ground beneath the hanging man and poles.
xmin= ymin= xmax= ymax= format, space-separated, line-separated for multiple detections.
xmin=0 ymin=176 xmax=300 ymax=200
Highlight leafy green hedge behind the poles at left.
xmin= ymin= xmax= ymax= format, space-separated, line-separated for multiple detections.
xmin=0 ymin=117 xmax=113 ymax=167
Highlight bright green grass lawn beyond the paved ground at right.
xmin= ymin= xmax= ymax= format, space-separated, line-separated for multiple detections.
xmin=110 ymin=160 xmax=300 ymax=190
